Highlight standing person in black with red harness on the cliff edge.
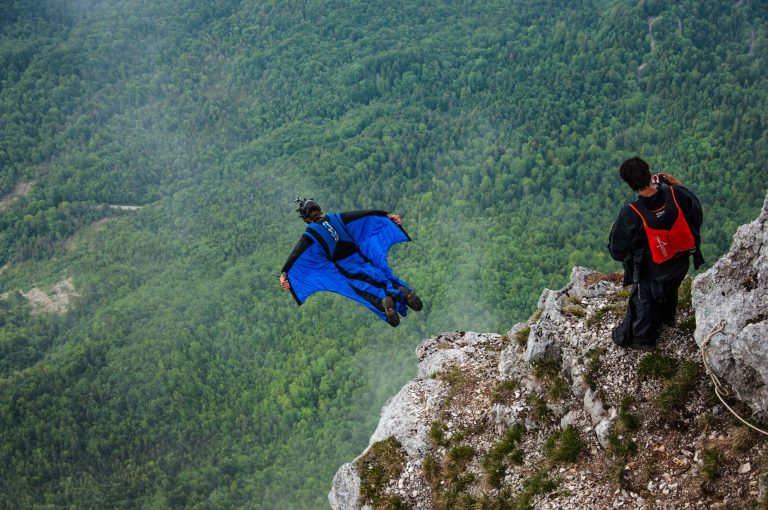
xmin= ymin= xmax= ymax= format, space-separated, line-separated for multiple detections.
xmin=608 ymin=157 xmax=704 ymax=351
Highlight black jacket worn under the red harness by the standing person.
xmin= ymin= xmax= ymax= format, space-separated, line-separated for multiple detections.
xmin=608 ymin=185 xmax=704 ymax=285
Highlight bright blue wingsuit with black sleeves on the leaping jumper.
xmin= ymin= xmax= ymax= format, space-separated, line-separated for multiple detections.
xmin=283 ymin=211 xmax=411 ymax=321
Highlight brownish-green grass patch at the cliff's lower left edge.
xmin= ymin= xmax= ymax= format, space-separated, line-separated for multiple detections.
xmin=355 ymin=436 xmax=405 ymax=508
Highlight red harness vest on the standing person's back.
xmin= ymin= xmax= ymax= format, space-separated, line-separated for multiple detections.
xmin=629 ymin=186 xmax=695 ymax=264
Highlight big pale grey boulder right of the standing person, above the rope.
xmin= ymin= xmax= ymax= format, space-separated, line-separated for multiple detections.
xmin=692 ymin=191 xmax=768 ymax=419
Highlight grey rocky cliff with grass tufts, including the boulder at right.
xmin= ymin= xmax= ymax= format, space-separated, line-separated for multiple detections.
xmin=329 ymin=196 xmax=768 ymax=510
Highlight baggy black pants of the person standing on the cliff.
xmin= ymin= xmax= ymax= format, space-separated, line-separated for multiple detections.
xmin=612 ymin=277 xmax=684 ymax=346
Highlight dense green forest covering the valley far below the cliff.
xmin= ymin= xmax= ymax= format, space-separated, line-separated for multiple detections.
xmin=0 ymin=0 xmax=768 ymax=509
